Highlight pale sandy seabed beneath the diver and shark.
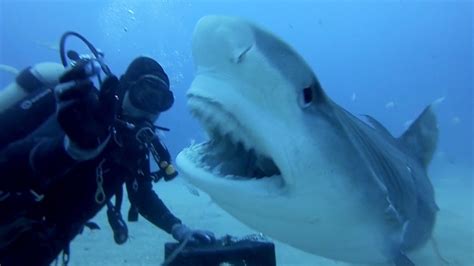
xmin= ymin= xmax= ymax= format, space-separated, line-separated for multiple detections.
xmin=68 ymin=160 xmax=474 ymax=266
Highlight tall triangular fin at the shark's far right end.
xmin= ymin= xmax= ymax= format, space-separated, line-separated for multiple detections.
xmin=399 ymin=105 xmax=439 ymax=167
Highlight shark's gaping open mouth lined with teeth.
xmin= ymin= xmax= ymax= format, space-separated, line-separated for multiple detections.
xmin=186 ymin=95 xmax=281 ymax=180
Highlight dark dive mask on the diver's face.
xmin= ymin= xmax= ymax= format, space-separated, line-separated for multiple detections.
xmin=128 ymin=75 xmax=174 ymax=114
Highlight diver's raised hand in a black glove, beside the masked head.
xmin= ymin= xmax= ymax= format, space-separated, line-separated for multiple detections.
xmin=55 ymin=61 xmax=118 ymax=160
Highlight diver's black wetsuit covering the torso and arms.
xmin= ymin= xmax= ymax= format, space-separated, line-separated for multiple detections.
xmin=0 ymin=119 xmax=181 ymax=266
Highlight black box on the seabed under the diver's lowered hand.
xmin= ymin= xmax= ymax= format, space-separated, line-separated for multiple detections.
xmin=162 ymin=234 xmax=276 ymax=266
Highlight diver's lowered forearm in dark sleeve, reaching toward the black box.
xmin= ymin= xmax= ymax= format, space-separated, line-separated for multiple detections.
xmin=127 ymin=176 xmax=181 ymax=234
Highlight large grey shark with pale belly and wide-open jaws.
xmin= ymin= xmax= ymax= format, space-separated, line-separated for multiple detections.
xmin=176 ymin=16 xmax=438 ymax=266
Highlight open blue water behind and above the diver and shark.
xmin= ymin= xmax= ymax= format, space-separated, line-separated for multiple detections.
xmin=0 ymin=0 xmax=474 ymax=264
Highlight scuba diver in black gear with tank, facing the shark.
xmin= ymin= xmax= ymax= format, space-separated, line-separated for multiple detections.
xmin=0 ymin=32 xmax=215 ymax=266
